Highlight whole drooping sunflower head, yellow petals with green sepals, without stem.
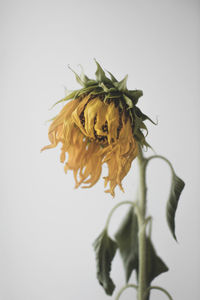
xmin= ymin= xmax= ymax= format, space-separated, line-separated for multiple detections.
xmin=42 ymin=61 xmax=151 ymax=196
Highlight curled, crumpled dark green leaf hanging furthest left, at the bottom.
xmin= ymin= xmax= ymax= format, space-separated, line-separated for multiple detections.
xmin=93 ymin=230 xmax=117 ymax=295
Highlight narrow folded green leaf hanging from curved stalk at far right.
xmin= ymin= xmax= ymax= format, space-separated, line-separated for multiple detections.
xmin=166 ymin=172 xmax=185 ymax=240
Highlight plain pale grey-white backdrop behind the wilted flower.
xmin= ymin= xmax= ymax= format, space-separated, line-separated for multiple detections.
xmin=0 ymin=0 xmax=200 ymax=300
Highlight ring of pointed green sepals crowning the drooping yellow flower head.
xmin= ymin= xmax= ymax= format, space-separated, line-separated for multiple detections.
xmin=50 ymin=60 xmax=156 ymax=147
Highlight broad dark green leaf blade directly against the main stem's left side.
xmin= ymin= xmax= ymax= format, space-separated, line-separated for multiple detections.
xmin=115 ymin=208 xmax=138 ymax=282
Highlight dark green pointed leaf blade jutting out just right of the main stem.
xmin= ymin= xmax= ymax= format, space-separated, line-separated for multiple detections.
xmin=143 ymin=237 xmax=169 ymax=286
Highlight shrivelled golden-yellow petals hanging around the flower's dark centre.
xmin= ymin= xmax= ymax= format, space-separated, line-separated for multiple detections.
xmin=42 ymin=95 xmax=138 ymax=197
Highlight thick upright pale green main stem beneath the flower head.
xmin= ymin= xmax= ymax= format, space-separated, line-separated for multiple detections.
xmin=137 ymin=148 xmax=147 ymax=300
